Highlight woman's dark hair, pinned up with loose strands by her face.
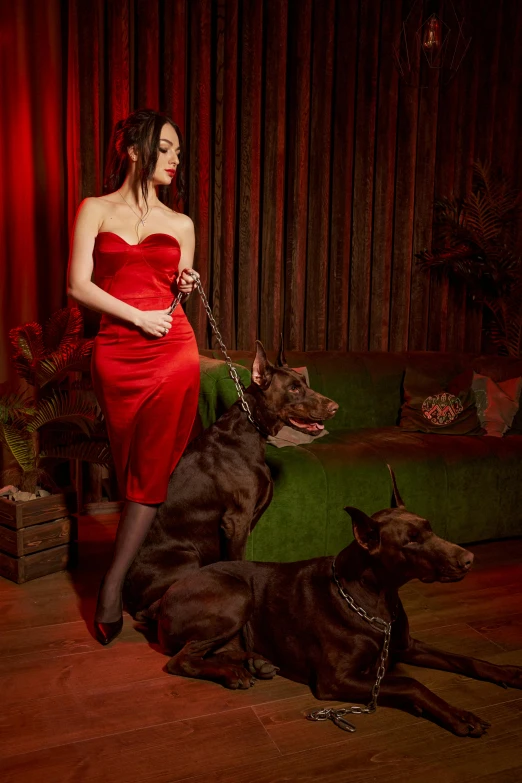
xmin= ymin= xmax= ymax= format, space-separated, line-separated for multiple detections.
xmin=103 ymin=109 xmax=186 ymax=208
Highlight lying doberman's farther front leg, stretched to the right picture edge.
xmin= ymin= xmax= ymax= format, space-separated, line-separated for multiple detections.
xmin=395 ymin=639 xmax=522 ymax=688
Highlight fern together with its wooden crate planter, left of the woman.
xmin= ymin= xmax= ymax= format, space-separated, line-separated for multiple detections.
xmin=0 ymin=308 xmax=110 ymax=582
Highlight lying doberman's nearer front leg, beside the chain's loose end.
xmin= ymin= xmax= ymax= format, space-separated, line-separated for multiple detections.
xmin=313 ymin=674 xmax=489 ymax=737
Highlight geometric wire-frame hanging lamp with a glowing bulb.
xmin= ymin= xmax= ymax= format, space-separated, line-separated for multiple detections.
xmin=393 ymin=0 xmax=471 ymax=87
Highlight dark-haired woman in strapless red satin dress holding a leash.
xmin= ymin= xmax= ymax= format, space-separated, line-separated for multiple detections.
xmin=68 ymin=109 xmax=199 ymax=644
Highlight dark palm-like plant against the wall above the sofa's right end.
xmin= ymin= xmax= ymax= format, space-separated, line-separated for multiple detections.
xmin=417 ymin=161 xmax=522 ymax=356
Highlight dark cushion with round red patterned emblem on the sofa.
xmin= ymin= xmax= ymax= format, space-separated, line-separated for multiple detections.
xmin=399 ymin=367 xmax=481 ymax=435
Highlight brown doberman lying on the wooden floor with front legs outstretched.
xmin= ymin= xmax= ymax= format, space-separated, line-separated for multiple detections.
xmin=152 ymin=480 xmax=522 ymax=737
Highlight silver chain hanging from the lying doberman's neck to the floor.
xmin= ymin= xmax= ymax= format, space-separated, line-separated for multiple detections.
xmin=306 ymin=559 xmax=395 ymax=732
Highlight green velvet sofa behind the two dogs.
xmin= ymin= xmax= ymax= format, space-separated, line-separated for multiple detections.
xmin=195 ymin=351 xmax=522 ymax=561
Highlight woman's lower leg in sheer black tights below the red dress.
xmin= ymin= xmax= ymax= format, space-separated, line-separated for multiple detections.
xmin=95 ymin=500 xmax=158 ymax=623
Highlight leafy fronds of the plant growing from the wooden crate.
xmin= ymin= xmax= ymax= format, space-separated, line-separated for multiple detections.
xmin=0 ymin=308 xmax=111 ymax=492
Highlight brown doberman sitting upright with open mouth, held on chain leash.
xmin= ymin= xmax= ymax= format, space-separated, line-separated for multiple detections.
xmin=123 ymin=342 xmax=339 ymax=620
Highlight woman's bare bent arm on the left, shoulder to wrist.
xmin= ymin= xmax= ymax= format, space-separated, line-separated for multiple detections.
xmin=67 ymin=198 xmax=141 ymax=326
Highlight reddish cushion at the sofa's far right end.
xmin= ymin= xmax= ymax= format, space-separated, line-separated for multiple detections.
xmin=472 ymin=373 xmax=522 ymax=438
